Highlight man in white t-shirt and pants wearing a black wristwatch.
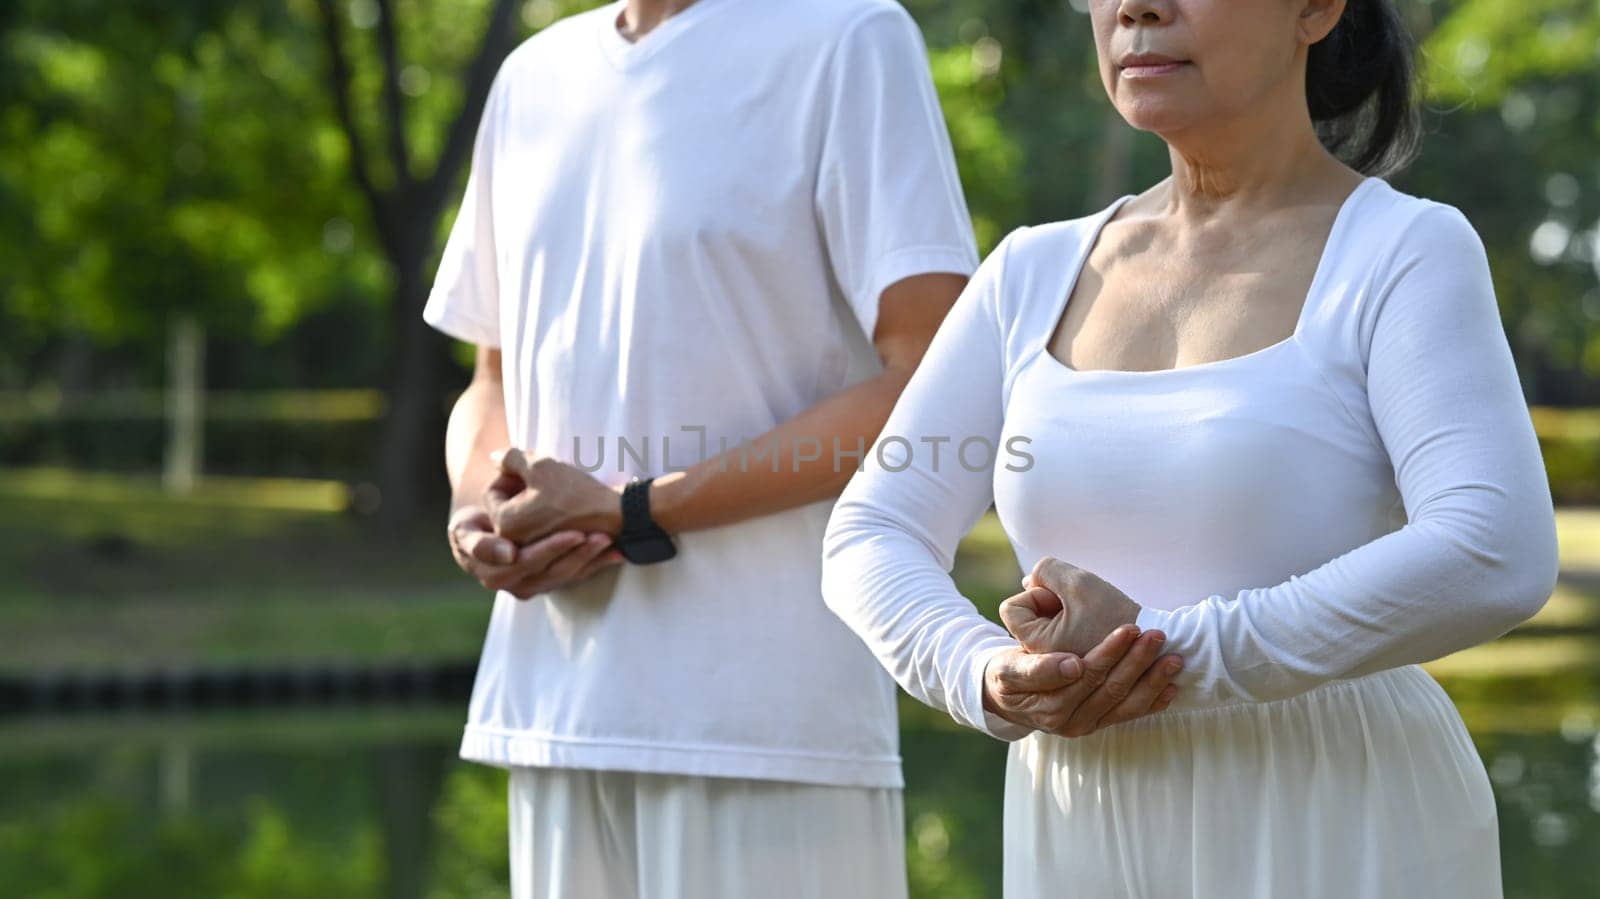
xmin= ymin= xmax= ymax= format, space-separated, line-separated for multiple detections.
xmin=424 ymin=0 xmax=1177 ymax=899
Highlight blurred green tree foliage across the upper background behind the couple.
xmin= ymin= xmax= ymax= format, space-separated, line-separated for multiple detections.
xmin=0 ymin=0 xmax=1600 ymax=405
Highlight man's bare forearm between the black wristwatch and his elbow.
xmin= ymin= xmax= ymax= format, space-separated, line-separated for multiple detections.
xmin=650 ymin=366 xmax=910 ymax=533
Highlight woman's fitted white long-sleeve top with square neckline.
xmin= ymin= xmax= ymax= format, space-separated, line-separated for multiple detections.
xmin=822 ymin=178 xmax=1557 ymax=739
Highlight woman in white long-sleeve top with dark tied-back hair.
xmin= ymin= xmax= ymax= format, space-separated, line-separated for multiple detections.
xmin=824 ymin=0 xmax=1557 ymax=899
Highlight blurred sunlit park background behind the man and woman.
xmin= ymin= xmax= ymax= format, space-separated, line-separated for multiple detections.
xmin=0 ymin=0 xmax=1600 ymax=899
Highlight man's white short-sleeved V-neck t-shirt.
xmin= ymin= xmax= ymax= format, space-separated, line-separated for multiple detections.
xmin=424 ymin=0 xmax=978 ymax=787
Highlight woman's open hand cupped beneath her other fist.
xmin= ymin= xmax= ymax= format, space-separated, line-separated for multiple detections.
xmin=984 ymin=614 xmax=1182 ymax=737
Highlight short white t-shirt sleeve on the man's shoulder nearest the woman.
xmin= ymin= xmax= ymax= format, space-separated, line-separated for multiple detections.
xmin=816 ymin=3 xmax=978 ymax=338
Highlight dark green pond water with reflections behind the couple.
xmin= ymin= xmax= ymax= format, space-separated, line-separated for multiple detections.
xmin=0 ymin=687 xmax=1600 ymax=899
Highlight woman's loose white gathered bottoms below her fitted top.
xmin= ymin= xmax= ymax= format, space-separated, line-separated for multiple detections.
xmin=1005 ymin=665 xmax=1501 ymax=899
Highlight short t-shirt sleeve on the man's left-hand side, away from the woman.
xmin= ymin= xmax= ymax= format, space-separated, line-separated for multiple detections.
xmin=422 ymin=69 xmax=506 ymax=347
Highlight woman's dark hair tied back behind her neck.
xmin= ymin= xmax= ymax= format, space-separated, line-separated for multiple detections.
xmin=1306 ymin=0 xmax=1422 ymax=176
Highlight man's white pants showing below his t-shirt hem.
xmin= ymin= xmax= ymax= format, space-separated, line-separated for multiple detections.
xmin=509 ymin=766 xmax=906 ymax=899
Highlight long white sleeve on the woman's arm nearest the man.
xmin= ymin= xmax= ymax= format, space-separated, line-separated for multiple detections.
xmin=822 ymin=232 xmax=1032 ymax=741
